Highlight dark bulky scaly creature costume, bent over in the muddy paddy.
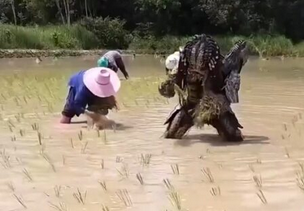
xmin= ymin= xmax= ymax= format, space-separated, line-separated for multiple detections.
xmin=159 ymin=34 xmax=247 ymax=142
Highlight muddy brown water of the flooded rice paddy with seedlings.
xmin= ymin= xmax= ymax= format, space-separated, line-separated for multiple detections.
xmin=0 ymin=57 xmax=304 ymax=211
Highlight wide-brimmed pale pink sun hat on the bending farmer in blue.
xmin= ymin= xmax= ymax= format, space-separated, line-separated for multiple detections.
xmin=83 ymin=67 xmax=120 ymax=97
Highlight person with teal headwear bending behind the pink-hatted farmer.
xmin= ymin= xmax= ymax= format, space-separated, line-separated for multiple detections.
xmin=97 ymin=51 xmax=129 ymax=79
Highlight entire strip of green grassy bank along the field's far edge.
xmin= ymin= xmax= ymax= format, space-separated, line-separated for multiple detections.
xmin=0 ymin=21 xmax=304 ymax=57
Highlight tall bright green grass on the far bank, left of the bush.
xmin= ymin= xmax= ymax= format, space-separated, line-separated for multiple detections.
xmin=0 ymin=24 xmax=98 ymax=49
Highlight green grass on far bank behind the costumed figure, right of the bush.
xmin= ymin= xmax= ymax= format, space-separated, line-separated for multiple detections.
xmin=129 ymin=36 xmax=304 ymax=57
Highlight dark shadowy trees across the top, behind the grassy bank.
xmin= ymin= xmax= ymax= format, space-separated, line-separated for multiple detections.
xmin=0 ymin=0 xmax=304 ymax=41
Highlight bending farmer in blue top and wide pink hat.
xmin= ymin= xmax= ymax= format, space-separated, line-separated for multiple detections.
xmin=60 ymin=67 xmax=120 ymax=124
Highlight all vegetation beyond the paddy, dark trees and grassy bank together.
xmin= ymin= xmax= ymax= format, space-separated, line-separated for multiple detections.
xmin=0 ymin=0 xmax=304 ymax=56
